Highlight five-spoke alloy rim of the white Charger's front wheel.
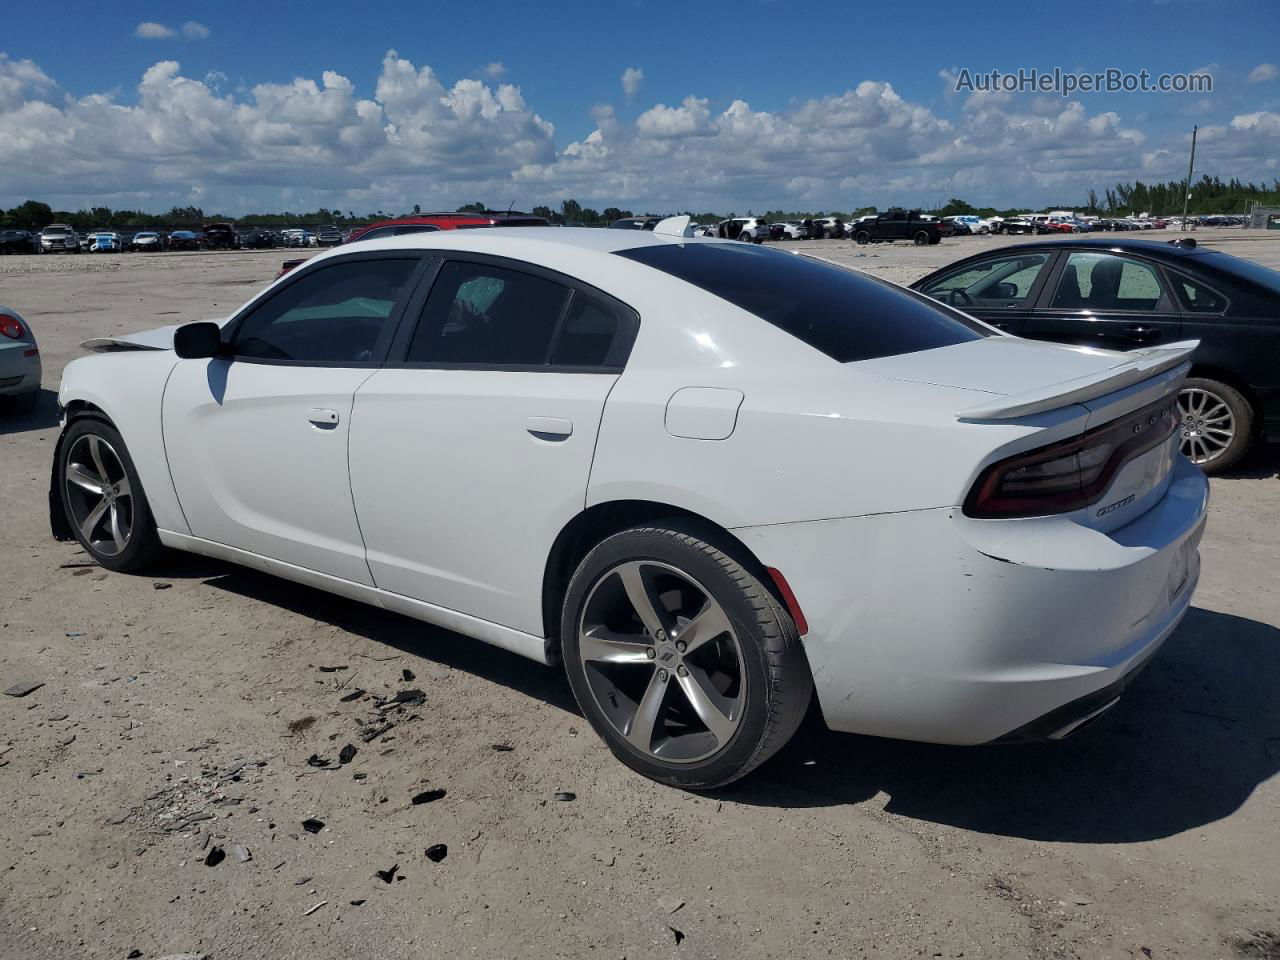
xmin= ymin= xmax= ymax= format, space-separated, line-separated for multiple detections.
xmin=64 ymin=434 xmax=134 ymax=557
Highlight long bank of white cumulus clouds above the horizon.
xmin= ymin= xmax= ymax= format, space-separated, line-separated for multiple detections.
xmin=0 ymin=51 xmax=1280 ymax=214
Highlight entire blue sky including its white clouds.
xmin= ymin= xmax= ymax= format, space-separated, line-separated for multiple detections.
xmin=0 ymin=0 xmax=1280 ymax=215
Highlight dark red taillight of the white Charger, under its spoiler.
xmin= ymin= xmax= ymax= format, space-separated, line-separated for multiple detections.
xmin=964 ymin=396 xmax=1179 ymax=520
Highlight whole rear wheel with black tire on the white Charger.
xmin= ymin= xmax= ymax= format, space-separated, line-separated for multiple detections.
xmin=561 ymin=521 xmax=813 ymax=790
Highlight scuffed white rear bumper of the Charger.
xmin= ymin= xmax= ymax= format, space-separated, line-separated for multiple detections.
xmin=735 ymin=457 xmax=1208 ymax=744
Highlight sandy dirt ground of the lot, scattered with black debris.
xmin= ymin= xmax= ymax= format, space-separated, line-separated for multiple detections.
xmin=0 ymin=230 xmax=1280 ymax=960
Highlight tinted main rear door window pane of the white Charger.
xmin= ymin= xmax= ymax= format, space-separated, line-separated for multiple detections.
xmin=407 ymin=261 xmax=570 ymax=366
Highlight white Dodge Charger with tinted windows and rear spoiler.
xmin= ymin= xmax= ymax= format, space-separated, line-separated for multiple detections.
xmin=50 ymin=224 xmax=1207 ymax=788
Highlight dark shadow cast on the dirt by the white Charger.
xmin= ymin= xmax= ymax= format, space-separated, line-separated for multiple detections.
xmin=175 ymin=557 xmax=1280 ymax=844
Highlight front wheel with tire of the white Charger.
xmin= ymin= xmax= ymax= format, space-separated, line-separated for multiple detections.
xmin=58 ymin=417 xmax=163 ymax=572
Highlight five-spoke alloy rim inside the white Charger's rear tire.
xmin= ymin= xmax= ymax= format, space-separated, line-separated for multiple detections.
xmin=577 ymin=561 xmax=746 ymax=763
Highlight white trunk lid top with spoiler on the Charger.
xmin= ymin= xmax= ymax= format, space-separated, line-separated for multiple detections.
xmin=851 ymin=337 xmax=1199 ymax=420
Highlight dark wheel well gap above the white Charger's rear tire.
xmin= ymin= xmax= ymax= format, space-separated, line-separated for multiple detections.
xmin=543 ymin=500 xmax=782 ymax=655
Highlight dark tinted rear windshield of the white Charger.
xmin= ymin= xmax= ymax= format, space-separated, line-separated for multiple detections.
xmin=618 ymin=243 xmax=988 ymax=364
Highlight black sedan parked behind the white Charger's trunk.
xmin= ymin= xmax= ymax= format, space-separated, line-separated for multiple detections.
xmin=911 ymin=237 xmax=1280 ymax=474
